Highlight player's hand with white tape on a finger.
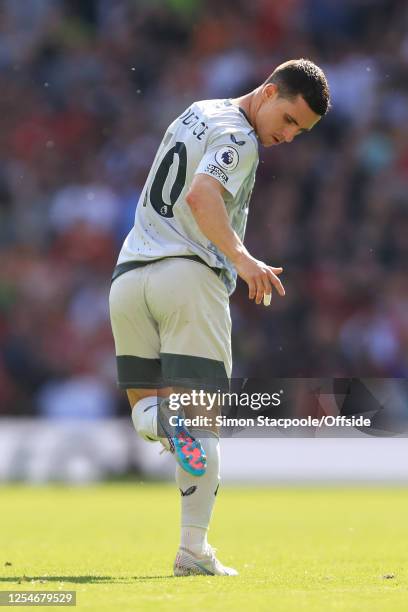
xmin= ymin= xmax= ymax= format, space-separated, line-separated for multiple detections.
xmin=234 ymin=253 xmax=285 ymax=304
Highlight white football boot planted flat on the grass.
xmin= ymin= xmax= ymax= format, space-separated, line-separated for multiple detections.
xmin=173 ymin=545 xmax=238 ymax=576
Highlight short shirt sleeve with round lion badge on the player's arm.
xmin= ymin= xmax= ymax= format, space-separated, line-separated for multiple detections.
xmin=195 ymin=128 xmax=257 ymax=197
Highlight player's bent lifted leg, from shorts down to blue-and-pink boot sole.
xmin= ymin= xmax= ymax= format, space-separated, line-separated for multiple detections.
xmin=109 ymin=264 xmax=206 ymax=476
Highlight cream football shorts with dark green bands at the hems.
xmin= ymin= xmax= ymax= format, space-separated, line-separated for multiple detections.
xmin=109 ymin=257 xmax=232 ymax=389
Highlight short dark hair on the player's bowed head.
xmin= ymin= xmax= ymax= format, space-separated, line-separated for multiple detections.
xmin=264 ymin=58 xmax=330 ymax=116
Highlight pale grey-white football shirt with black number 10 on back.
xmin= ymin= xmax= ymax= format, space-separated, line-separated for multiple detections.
xmin=118 ymin=100 xmax=259 ymax=294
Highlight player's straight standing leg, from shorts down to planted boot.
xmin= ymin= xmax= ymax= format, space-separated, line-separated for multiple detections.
xmin=146 ymin=260 xmax=235 ymax=575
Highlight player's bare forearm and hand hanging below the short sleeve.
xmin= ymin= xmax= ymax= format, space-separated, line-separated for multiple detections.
xmin=186 ymin=174 xmax=285 ymax=304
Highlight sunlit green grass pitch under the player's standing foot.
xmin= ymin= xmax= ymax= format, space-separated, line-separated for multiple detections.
xmin=0 ymin=482 xmax=408 ymax=612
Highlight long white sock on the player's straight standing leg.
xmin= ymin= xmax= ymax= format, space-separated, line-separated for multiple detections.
xmin=176 ymin=431 xmax=220 ymax=555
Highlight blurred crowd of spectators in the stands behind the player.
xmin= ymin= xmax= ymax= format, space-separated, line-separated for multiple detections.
xmin=0 ymin=0 xmax=408 ymax=418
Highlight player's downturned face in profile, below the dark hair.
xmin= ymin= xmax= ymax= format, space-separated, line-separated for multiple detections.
xmin=255 ymin=84 xmax=321 ymax=147
